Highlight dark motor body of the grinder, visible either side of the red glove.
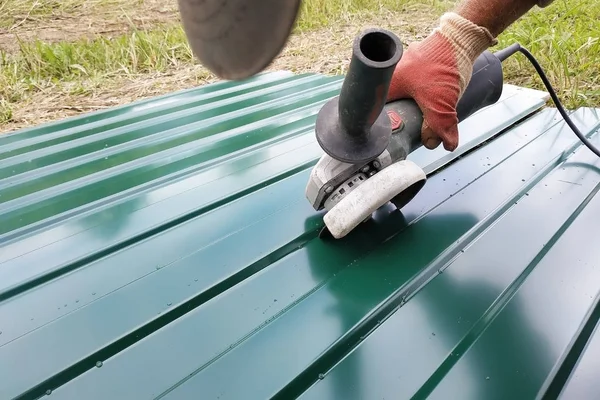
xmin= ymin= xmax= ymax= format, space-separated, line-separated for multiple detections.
xmin=384 ymin=51 xmax=504 ymax=160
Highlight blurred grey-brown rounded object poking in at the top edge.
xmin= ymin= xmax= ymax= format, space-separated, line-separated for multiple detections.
xmin=178 ymin=0 xmax=301 ymax=80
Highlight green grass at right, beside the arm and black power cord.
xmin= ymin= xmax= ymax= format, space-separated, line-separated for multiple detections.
xmin=498 ymin=0 xmax=600 ymax=108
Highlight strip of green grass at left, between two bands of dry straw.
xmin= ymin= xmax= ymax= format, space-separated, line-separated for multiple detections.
xmin=0 ymin=26 xmax=193 ymax=123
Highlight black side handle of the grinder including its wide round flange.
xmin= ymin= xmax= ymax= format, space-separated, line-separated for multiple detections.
xmin=315 ymin=29 xmax=402 ymax=164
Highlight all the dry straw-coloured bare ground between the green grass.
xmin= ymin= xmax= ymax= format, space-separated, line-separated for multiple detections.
xmin=0 ymin=5 xmax=438 ymax=132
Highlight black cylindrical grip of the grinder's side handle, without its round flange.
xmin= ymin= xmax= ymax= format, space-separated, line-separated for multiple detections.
xmin=339 ymin=29 xmax=402 ymax=141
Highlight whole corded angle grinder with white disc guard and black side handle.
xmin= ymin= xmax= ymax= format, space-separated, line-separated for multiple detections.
xmin=306 ymin=29 xmax=512 ymax=239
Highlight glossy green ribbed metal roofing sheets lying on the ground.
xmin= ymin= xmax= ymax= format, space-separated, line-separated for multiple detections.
xmin=0 ymin=72 xmax=600 ymax=400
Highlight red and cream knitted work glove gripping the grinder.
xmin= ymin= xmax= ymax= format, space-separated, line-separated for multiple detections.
xmin=388 ymin=13 xmax=496 ymax=151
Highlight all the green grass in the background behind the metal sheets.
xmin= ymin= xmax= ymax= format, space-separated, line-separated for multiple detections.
xmin=0 ymin=0 xmax=600 ymax=123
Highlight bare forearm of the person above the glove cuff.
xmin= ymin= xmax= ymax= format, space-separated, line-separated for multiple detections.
xmin=455 ymin=0 xmax=552 ymax=37
